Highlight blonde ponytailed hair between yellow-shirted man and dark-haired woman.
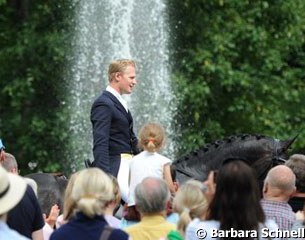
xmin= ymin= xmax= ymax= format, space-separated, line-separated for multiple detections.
xmin=173 ymin=180 xmax=208 ymax=235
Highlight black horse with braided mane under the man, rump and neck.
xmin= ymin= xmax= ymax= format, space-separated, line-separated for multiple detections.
xmin=26 ymin=134 xmax=296 ymax=214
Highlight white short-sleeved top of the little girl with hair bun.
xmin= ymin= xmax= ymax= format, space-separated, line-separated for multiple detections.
xmin=128 ymin=151 xmax=172 ymax=206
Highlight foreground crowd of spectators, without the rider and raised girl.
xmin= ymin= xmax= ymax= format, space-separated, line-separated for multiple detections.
xmin=0 ymin=142 xmax=305 ymax=240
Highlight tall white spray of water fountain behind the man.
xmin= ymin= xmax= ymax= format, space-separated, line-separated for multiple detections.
xmin=67 ymin=0 xmax=175 ymax=169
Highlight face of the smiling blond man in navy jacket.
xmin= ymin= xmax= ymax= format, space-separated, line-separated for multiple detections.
xmin=117 ymin=66 xmax=137 ymax=95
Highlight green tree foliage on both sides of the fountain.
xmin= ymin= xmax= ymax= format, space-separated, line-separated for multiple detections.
xmin=0 ymin=0 xmax=305 ymax=174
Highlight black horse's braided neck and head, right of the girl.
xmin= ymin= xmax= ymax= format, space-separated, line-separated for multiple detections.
xmin=173 ymin=134 xmax=295 ymax=183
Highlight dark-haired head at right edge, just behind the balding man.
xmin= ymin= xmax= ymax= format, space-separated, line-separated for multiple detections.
xmin=285 ymin=154 xmax=305 ymax=193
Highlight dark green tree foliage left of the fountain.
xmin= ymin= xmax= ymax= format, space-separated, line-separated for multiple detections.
xmin=0 ymin=0 xmax=72 ymax=173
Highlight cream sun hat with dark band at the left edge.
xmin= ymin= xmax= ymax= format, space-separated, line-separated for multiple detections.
xmin=0 ymin=166 xmax=26 ymax=221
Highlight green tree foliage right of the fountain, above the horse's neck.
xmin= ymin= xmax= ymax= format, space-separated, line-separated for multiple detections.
xmin=169 ymin=0 xmax=305 ymax=154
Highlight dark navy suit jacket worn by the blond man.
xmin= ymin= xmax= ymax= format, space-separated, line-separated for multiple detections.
xmin=91 ymin=91 xmax=138 ymax=177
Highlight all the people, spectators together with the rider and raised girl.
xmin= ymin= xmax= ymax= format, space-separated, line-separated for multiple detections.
xmin=0 ymin=59 xmax=305 ymax=240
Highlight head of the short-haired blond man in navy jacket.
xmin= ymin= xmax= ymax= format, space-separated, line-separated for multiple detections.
xmin=108 ymin=59 xmax=137 ymax=95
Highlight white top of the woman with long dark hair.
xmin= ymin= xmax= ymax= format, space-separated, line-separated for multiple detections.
xmin=185 ymin=218 xmax=279 ymax=240
